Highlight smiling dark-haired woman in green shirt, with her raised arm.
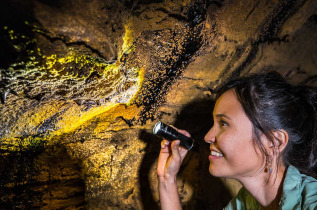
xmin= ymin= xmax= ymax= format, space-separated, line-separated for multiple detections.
xmin=157 ymin=72 xmax=317 ymax=210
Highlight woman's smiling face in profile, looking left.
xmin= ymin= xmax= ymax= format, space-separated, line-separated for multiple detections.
xmin=205 ymin=90 xmax=264 ymax=180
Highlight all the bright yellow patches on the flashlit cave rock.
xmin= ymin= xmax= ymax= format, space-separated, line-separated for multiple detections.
xmin=1 ymin=19 xmax=144 ymax=151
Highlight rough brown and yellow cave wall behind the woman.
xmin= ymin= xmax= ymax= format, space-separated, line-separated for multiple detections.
xmin=0 ymin=0 xmax=317 ymax=209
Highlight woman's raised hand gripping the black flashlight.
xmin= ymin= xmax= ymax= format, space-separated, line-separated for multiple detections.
xmin=157 ymin=129 xmax=190 ymax=181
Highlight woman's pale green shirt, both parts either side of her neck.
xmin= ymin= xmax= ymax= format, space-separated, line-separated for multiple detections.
xmin=224 ymin=166 xmax=317 ymax=210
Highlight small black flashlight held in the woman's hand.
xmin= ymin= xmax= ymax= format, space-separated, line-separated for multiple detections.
xmin=153 ymin=121 xmax=197 ymax=150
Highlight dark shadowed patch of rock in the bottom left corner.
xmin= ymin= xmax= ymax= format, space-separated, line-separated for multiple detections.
xmin=0 ymin=145 xmax=86 ymax=209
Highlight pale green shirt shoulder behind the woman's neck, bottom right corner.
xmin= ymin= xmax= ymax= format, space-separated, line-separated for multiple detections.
xmin=280 ymin=166 xmax=317 ymax=209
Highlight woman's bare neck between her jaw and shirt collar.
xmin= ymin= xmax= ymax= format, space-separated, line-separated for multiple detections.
xmin=238 ymin=166 xmax=285 ymax=209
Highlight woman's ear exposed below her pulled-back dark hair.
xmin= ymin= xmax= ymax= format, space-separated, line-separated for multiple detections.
xmin=268 ymin=129 xmax=288 ymax=154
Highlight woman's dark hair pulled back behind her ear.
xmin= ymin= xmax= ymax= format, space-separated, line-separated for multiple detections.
xmin=216 ymin=71 xmax=317 ymax=177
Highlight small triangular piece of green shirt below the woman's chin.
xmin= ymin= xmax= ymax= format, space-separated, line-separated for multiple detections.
xmin=224 ymin=187 xmax=259 ymax=210
